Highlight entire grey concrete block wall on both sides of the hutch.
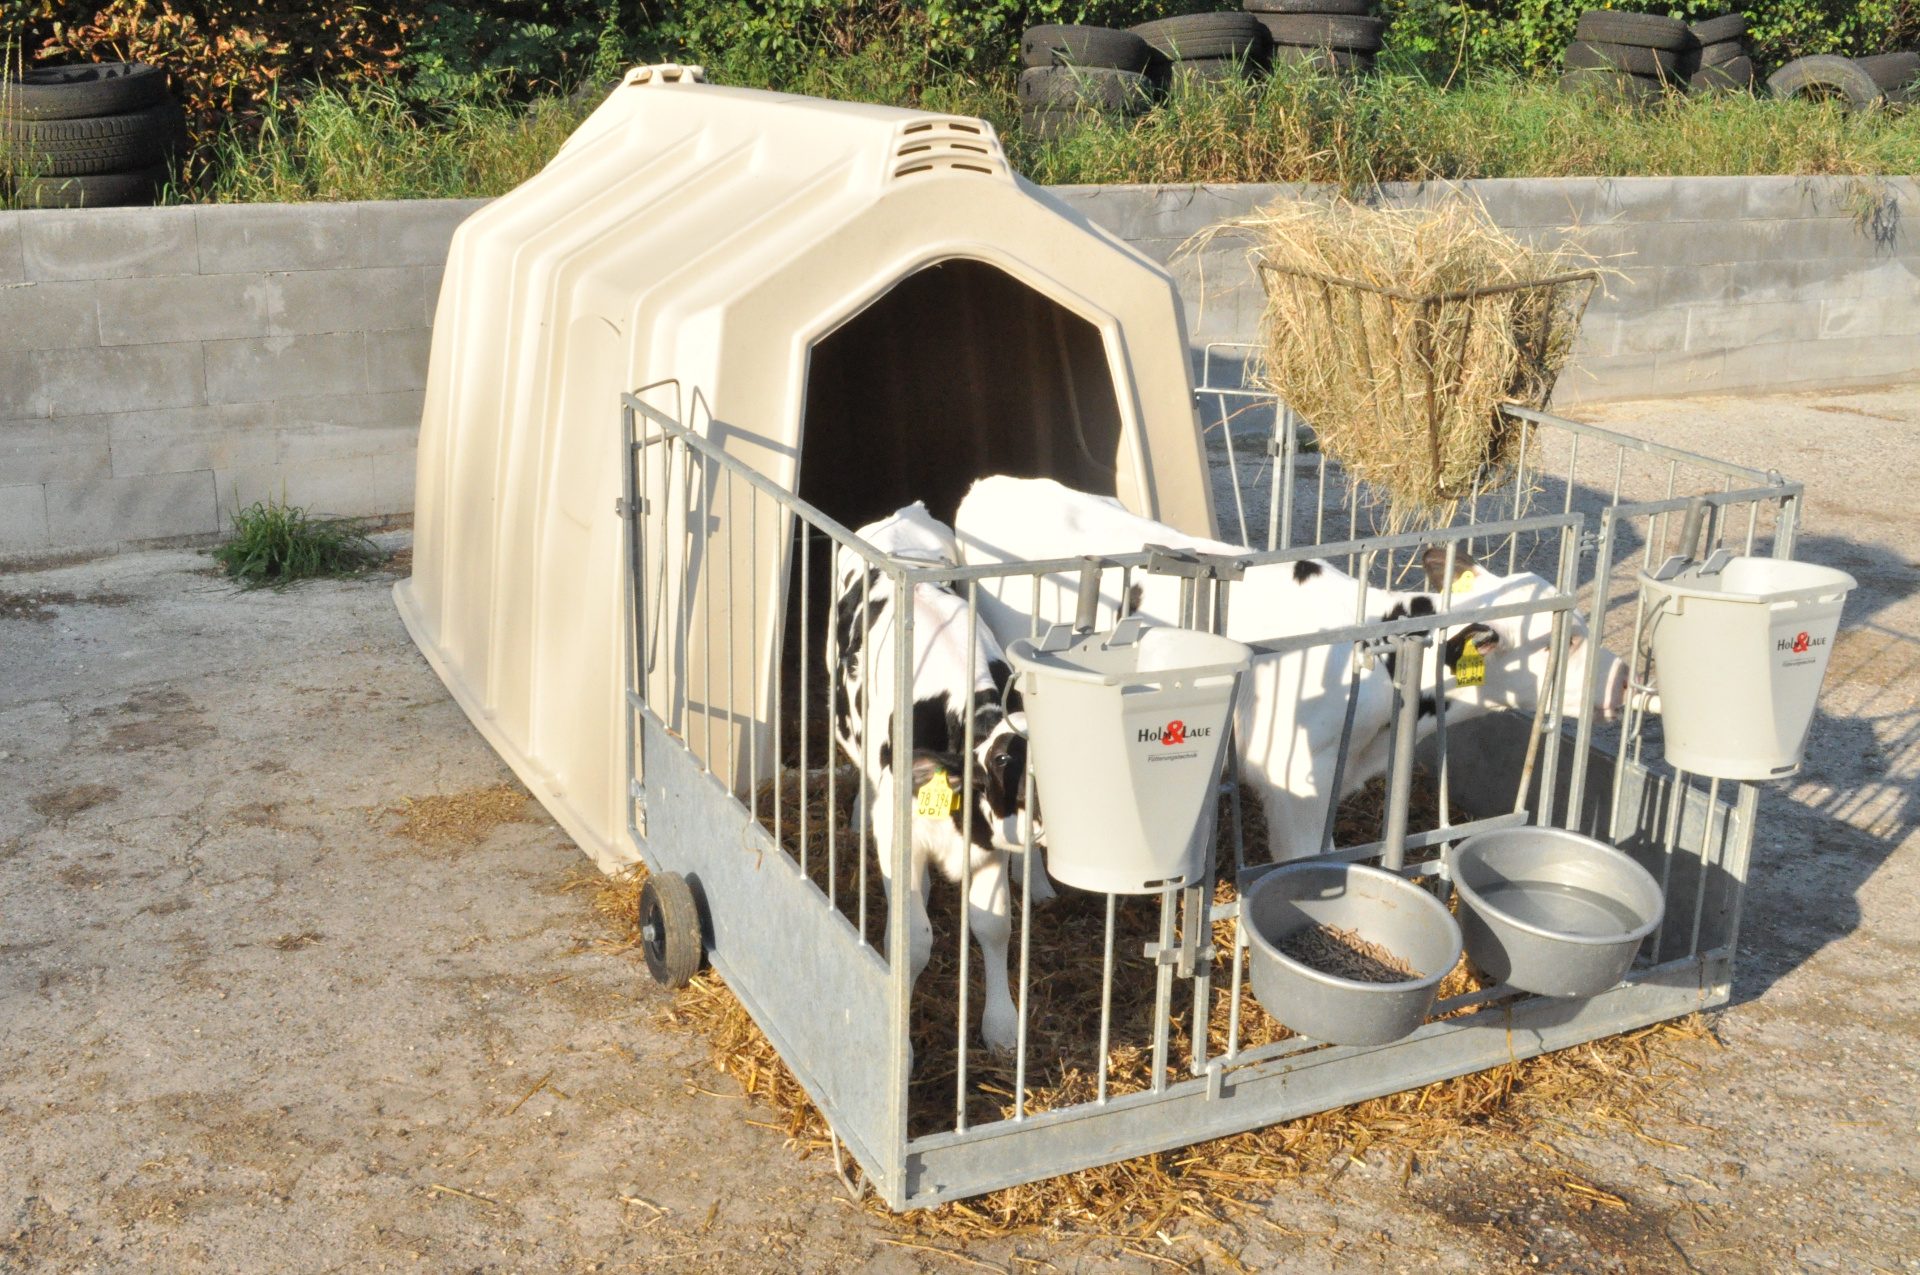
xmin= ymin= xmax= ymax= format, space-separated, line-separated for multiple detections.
xmin=0 ymin=177 xmax=1920 ymax=559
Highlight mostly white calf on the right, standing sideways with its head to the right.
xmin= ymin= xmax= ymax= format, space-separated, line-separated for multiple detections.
xmin=954 ymin=478 xmax=1624 ymax=860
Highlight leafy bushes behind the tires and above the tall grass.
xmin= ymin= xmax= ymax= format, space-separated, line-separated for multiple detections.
xmin=0 ymin=0 xmax=1920 ymax=131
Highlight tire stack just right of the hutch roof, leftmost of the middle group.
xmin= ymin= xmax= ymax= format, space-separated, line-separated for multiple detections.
xmin=1020 ymin=25 xmax=1152 ymax=140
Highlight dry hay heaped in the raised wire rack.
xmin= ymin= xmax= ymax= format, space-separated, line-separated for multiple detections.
xmin=1196 ymin=198 xmax=1594 ymax=528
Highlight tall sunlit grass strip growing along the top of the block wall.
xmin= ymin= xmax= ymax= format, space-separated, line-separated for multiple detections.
xmin=172 ymin=61 xmax=1920 ymax=202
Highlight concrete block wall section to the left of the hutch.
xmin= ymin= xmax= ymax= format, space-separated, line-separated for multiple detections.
xmin=0 ymin=200 xmax=478 ymax=557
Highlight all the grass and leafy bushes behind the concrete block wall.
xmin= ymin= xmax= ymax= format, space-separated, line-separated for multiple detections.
xmin=0 ymin=0 xmax=1920 ymax=205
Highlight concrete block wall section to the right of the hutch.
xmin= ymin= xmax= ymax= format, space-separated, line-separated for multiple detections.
xmin=1054 ymin=177 xmax=1920 ymax=405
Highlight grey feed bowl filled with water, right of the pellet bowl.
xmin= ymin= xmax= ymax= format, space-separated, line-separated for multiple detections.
xmin=1448 ymin=828 xmax=1665 ymax=997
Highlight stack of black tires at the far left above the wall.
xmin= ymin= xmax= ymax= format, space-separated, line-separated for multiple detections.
xmin=0 ymin=61 xmax=184 ymax=207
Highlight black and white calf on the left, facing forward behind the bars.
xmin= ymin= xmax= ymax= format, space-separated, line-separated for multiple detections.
xmin=828 ymin=503 xmax=1052 ymax=1048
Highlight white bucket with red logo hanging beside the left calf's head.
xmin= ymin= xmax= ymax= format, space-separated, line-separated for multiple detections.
xmin=1006 ymin=620 xmax=1254 ymax=895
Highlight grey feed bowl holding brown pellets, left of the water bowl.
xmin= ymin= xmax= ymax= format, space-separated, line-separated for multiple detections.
xmin=1240 ymin=860 xmax=1461 ymax=1045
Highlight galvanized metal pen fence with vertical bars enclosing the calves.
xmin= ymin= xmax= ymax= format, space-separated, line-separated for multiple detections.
xmin=622 ymin=366 xmax=1801 ymax=1208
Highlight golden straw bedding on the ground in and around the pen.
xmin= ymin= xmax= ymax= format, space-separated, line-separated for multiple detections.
xmin=582 ymin=776 xmax=1707 ymax=1240
